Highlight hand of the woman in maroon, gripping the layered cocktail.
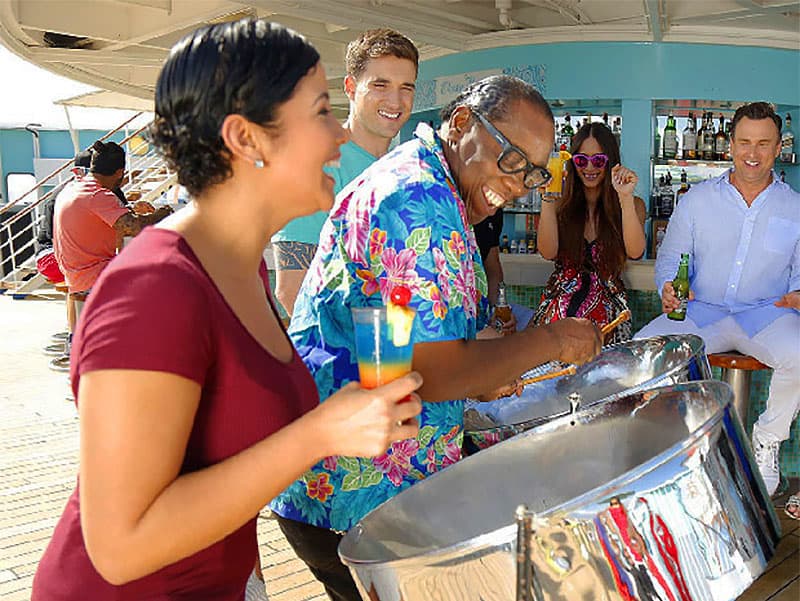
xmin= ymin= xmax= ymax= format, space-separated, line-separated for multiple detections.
xmin=314 ymin=372 xmax=422 ymax=457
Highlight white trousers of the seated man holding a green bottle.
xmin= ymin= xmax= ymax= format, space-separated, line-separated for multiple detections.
xmin=634 ymin=312 xmax=800 ymax=442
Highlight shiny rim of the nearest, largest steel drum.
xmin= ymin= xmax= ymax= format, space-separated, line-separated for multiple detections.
xmin=338 ymin=380 xmax=733 ymax=570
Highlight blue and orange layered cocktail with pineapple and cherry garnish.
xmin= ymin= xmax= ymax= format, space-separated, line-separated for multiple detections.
xmin=352 ymin=307 xmax=414 ymax=388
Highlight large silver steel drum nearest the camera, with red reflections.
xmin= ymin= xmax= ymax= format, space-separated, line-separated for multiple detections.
xmin=339 ymin=381 xmax=779 ymax=601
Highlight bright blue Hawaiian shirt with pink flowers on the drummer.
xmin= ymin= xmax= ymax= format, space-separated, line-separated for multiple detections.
xmin=272 ymin=124 xmax=487 ymax=530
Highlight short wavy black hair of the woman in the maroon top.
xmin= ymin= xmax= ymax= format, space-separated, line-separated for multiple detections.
xmin=149 ymin=19 xmax=319 ymax=197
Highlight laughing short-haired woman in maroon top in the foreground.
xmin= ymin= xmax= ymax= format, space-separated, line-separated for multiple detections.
xmin=33 ymin=19 xmax=421 ymax=601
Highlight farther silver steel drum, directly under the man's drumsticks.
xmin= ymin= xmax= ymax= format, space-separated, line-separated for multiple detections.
xmin=464 ymin=334 xmax=711 ymax=454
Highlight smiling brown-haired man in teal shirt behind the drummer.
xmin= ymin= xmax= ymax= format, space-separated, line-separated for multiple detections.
xmin=272 ymin=29 xmax=419 ymax=317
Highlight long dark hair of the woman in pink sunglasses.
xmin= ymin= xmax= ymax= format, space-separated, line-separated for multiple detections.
xmin=558 ymin=122 xmax=627 ymax=278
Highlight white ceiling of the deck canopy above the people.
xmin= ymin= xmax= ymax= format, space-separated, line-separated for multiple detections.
xmin=0 ymin=0 xmax=800 ymax=115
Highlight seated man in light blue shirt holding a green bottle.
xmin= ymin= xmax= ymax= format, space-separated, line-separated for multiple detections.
xmin=636 ymin=102 xmax=800 ymax=494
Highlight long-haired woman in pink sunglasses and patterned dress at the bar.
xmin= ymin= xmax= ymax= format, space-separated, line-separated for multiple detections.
xmin=532 ymin=123 xmax=646 ymax=343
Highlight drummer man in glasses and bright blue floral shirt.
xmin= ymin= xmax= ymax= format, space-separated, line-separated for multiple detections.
xmin=272 ymin=76 xmax=600 ymax=601
